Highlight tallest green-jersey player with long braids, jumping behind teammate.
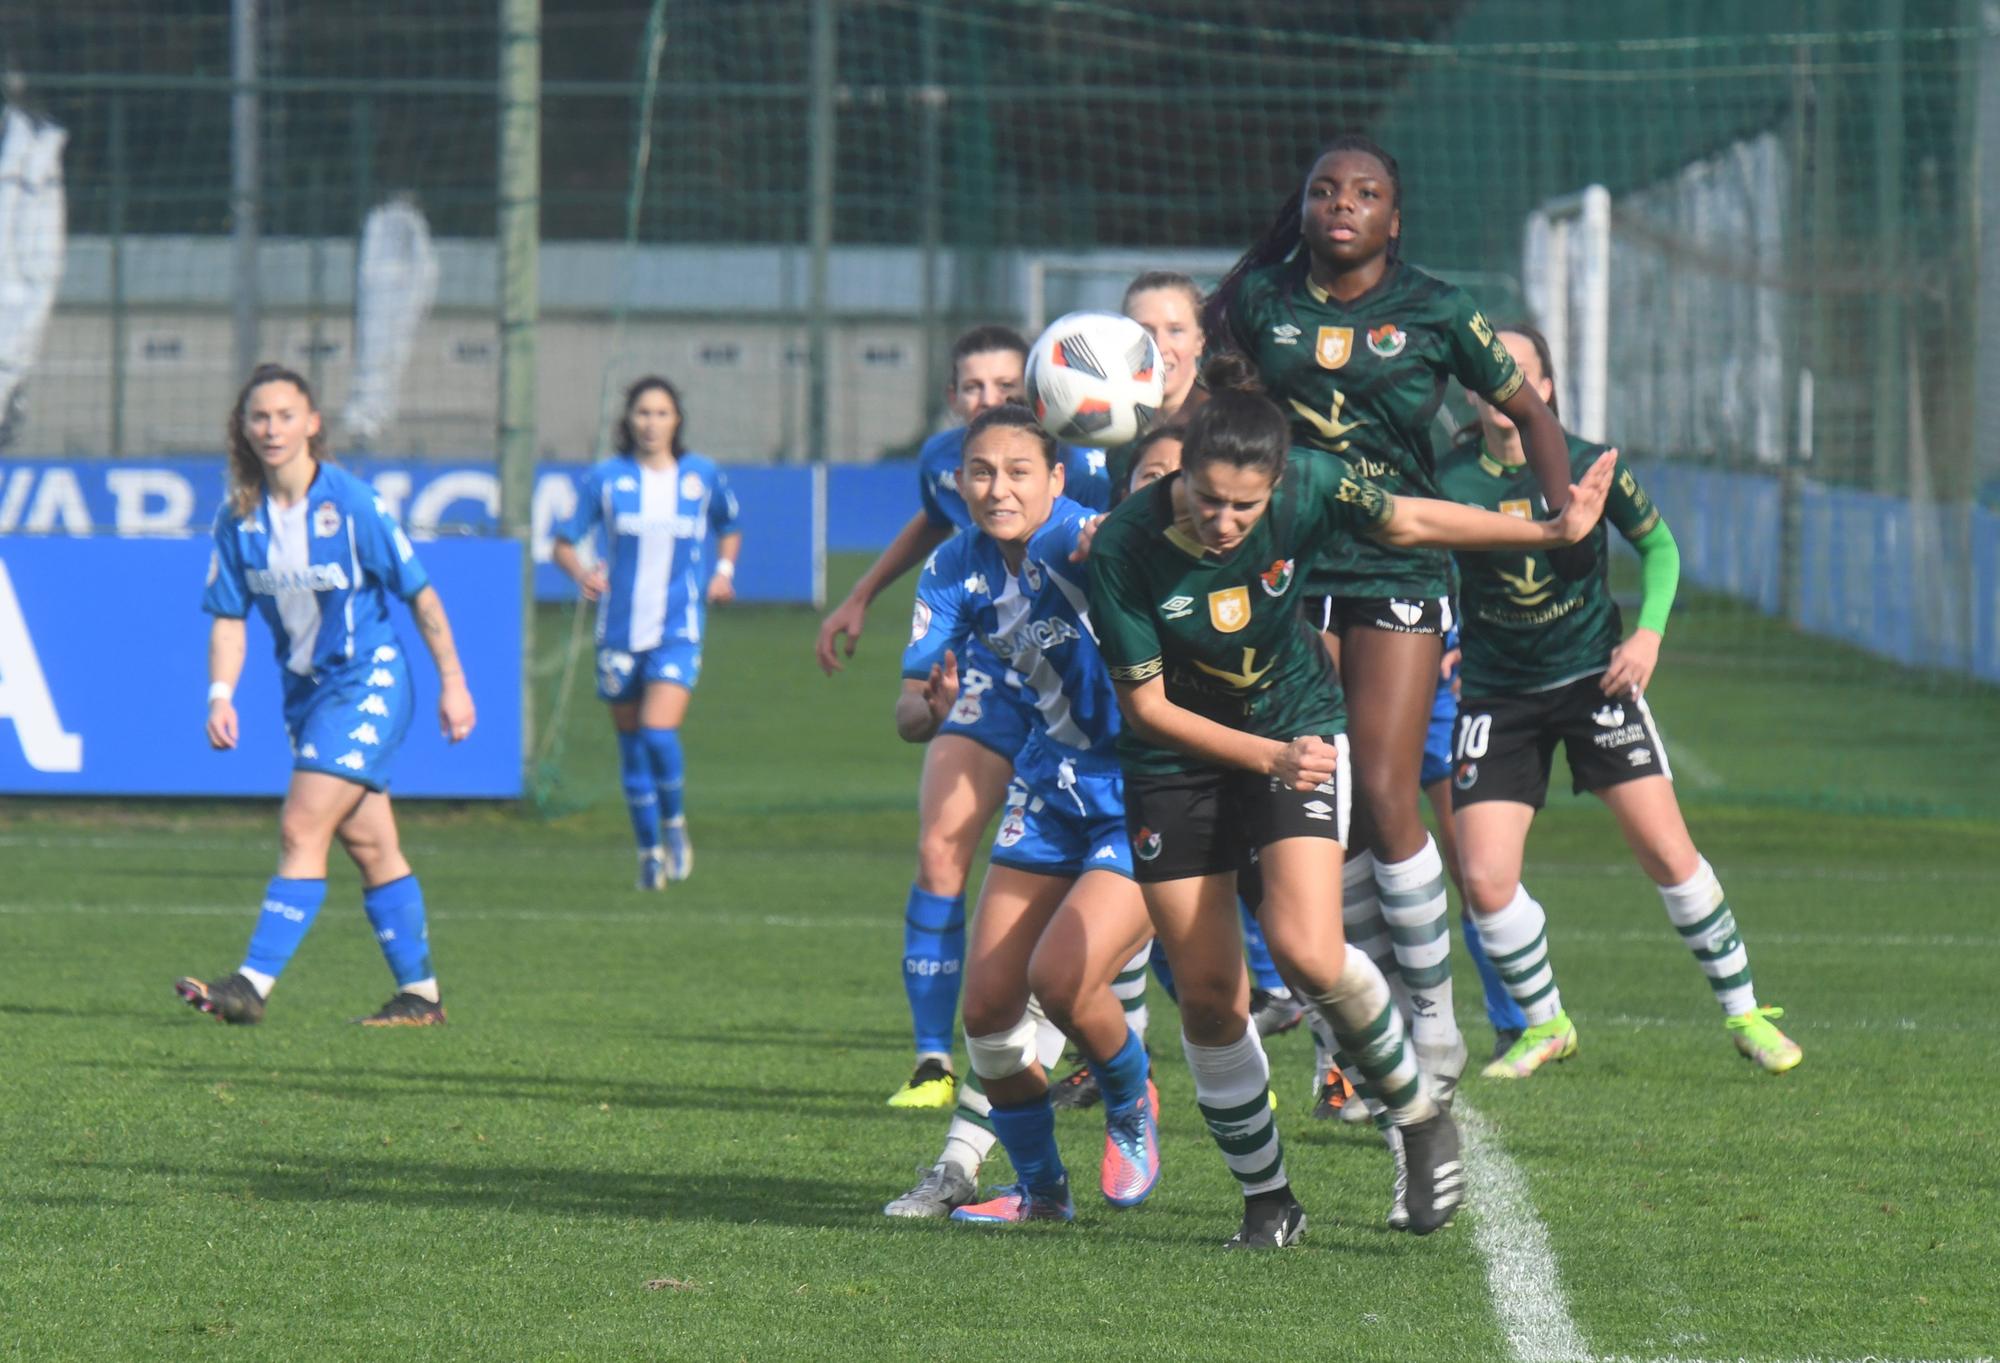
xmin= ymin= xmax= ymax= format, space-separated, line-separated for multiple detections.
xmin=1204 ymin=136 xmax=1570 ymax=1093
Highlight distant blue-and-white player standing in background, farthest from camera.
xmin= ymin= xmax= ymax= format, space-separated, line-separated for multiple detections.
xmin=554 ymin=376 xmax=742 ymax=889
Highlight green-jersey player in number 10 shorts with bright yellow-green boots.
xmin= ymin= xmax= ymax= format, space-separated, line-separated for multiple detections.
xmin=1440 ymin=326 xmax=1802 ymax=1079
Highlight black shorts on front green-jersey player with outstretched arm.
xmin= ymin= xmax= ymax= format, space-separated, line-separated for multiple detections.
xmin=1126 ymin=733 xmax=1350 ymax=885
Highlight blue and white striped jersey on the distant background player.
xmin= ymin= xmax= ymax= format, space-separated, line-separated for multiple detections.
xmin=556 ymin=454 xmax=738 ymax=654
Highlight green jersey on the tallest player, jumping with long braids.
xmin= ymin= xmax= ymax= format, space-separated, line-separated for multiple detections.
xmin=1230 ymin=254 xmax=1522 ymax=598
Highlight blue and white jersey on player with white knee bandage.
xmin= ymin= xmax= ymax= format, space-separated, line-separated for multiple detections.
xmin=902 ymin=498 xmax=1118 ymax=755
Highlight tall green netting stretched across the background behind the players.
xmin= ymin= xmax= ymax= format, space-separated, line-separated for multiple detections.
xmin=0 ymin=0 xmax=2000 ymax=813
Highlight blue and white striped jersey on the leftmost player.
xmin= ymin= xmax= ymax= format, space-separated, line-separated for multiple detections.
xmin=202 ymin=464 xmax=430 ymax=685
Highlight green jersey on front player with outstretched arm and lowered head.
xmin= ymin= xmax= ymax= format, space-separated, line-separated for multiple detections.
xmin=1090 ymin=450 xmax=1390 ymax=771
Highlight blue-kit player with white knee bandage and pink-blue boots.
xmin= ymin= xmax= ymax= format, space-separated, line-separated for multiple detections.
xmin=888 ymin=406 xmax=1160 ymax=1223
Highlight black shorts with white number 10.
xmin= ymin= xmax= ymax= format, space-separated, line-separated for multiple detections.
xmin=1452 ymin=672 xmax=1674 ymax=809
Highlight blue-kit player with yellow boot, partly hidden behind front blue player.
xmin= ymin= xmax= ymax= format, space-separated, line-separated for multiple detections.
xmin=816 ymin=324 xmax=1110 ymax=1107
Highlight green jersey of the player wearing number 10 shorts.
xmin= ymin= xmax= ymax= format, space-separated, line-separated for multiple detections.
xmin=1438 ymin=436 xmax=1660 ymax=695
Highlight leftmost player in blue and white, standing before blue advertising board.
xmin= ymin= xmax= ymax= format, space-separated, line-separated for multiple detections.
xmin=174 ymin=364 xmax=474 ymax=1027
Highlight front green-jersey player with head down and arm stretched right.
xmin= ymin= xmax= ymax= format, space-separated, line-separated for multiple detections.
xmin=1090 ymin=371 xmax=1610 ymax=1247
